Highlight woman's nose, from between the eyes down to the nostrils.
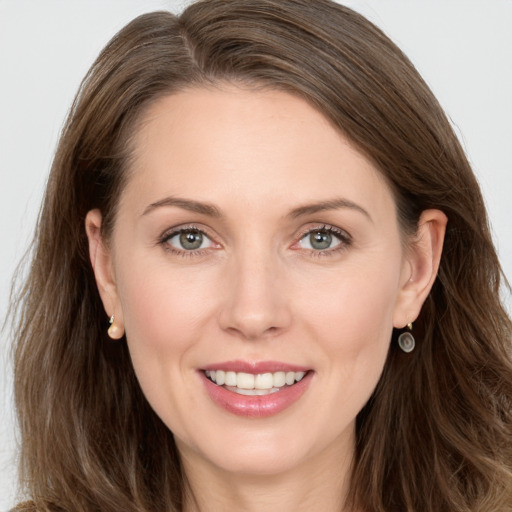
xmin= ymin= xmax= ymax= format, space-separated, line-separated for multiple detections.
xmin=219 ymin=247 xmax=292 ymax=340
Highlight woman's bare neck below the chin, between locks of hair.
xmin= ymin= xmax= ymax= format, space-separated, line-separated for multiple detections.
xmin=182 ymin=432 xmax=354 ymax=512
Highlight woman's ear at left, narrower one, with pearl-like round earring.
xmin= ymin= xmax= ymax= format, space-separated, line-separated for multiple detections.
xmin=85 ymin=209 xmax=124 ymax=338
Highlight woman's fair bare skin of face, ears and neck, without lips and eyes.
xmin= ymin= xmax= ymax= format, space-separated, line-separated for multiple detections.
xmin=86 ymin=85 xmax=446 ymax=512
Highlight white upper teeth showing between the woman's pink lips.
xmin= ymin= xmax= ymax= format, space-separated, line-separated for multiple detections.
xmin=204 ymin=370 xmax=308 ymax=396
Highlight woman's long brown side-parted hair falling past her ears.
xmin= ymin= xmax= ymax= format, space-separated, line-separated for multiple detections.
xmin=10 ymin=0 xmax=512 ymax=512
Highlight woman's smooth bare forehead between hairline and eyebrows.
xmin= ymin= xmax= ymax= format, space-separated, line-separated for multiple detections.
xmin=125 ymin=86 xmax=393 ymax=218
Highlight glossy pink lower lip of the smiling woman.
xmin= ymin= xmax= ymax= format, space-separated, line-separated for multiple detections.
xmin=200 ymin=371 xmax=313 ymax=418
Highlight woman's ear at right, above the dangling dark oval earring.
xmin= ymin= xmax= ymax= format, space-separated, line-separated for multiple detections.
xmin=393 ymin=210 xmax=448 ymax=328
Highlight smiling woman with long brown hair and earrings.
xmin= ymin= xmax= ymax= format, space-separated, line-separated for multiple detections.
xmin=9 ymin=0 xmax=512 ymax=512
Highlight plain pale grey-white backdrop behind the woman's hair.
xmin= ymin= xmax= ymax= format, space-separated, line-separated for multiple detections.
xmin=0 ymin=0 xmax=512 ymax=510
